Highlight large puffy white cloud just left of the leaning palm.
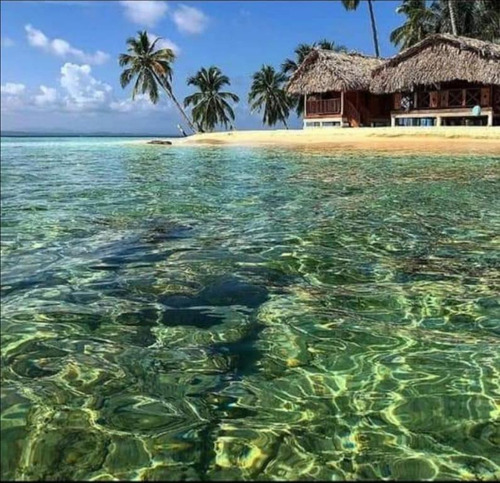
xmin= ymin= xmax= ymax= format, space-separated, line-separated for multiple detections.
xmin=60 ymin=62 xmax=112 ymax=111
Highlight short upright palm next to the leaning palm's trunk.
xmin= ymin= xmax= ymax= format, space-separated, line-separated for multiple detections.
xmin=184 ymin=66 xmax=240 ymax=131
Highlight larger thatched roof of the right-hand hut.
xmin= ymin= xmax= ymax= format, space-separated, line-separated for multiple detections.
xmin=370 ymin=34 xmax=500 ymax=94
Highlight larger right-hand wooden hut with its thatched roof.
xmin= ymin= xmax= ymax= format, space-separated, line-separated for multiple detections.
xmin=370 ymin=34 xmax=500 ymax=126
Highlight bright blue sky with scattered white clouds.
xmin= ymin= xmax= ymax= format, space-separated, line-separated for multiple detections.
xmin=1 ymin=0 xmax=403 ymax=134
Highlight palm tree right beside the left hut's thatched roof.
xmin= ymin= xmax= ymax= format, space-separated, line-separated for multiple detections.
xmin=248 ymin=65 xmax=294 ymax=129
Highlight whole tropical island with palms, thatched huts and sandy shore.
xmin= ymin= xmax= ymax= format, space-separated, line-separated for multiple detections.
xmin=119 ymin=0 xmax=500 ymax=150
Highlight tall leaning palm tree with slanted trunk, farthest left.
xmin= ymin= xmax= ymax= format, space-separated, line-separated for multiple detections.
xmin=119 ymin=30 xmax=196 ymax=132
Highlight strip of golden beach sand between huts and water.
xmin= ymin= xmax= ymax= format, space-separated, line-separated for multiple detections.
xmin=135 ymin=126 xmax=500 ymax=155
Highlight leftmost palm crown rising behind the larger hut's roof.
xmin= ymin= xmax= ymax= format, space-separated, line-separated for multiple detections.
xmin=390 ymin=0 xmax=436 ymax=49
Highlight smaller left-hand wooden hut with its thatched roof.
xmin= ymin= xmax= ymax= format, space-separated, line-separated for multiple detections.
xmin=286 ymin=49 xmax=391 ymax=128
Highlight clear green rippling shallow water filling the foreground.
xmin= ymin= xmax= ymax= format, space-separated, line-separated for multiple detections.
xmin=1 ymin=138 xmax=500 ymax=480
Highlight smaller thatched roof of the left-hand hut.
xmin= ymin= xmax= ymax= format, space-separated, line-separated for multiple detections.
xmin=286 ymin=49 xmax=383 ymax=94
